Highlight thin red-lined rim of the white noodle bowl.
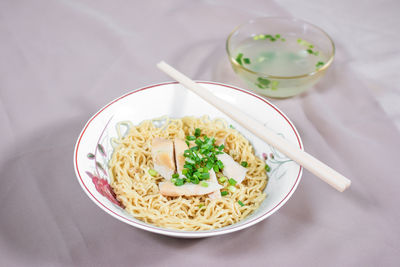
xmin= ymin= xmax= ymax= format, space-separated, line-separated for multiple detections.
xmin=74 ymin=81 xmax=303 ymax=238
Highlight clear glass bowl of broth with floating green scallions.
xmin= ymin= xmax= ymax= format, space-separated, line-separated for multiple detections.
xmin=226 ymin=17 xmax=335 ymax=98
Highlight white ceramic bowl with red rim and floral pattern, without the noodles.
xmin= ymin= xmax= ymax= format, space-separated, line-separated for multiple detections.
xmin=74 ymin=82 xmax=303 ymax=238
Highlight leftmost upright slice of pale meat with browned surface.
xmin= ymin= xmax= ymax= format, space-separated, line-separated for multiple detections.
xmin=151 ymin=137 xmax=175 ymax=180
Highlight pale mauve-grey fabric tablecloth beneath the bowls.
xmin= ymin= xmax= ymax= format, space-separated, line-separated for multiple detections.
xmin=0 ymin=0 xmax=400 ymax=266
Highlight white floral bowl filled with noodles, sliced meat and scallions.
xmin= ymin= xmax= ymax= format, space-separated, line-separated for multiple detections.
xmin=74 ymin=82 xmax=303 ymax=238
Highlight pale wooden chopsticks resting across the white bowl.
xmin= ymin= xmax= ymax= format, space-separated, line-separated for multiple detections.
xmin=157 ymin=61 xmax=351 ymax=192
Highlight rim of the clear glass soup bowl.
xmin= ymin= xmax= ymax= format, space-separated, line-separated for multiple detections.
xmin=225 ymin=17 xmax=336 ymax=80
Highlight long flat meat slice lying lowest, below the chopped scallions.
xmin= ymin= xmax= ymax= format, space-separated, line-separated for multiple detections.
xmin=158 ymin=182 xmax=222 ymax=197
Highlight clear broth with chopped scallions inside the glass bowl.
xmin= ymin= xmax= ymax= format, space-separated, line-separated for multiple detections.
xmin=232 ymin=34 xmax=329 ymax=97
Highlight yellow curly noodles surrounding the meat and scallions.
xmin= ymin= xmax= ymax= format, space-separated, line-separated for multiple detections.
xmin=109 ymin=116 xmax=268 ymax=231
